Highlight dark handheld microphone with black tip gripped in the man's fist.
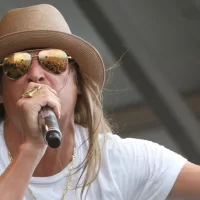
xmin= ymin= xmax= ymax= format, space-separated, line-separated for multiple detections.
xmin=38 ymin=106 xmax=62 ymax=148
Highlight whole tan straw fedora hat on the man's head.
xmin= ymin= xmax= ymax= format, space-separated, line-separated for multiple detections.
xmin=0 ymin=4 xmax=105 ymax=89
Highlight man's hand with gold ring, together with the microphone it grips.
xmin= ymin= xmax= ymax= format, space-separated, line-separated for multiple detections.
xmin=18 ymin=83 xmax=62 ymax=148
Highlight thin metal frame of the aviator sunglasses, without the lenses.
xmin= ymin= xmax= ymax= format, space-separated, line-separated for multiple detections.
xmin=0 ymin=48 xmax=74 ymax=81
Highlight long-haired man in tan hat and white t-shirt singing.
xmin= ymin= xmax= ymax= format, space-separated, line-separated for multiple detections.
xmin=0 ymin=4 xmax=200 ymax=200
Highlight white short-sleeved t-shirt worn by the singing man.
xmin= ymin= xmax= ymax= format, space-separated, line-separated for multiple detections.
xmin=0 ymin=123 xmax=186 ymax=200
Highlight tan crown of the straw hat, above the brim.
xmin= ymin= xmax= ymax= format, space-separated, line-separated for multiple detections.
xmin=0 ymin=4 xmax=71 ymax=37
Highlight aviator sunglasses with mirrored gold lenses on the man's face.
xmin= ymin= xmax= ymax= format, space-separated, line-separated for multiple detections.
xmin=0 ymin=49 xmax=71 ymax=80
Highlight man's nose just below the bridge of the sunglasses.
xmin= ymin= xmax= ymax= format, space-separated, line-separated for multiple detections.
xmin=27 ymin=58 xmax=45 ymax=83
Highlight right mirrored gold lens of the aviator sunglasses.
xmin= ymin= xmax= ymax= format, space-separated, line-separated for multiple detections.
xmin=38 ymin=49 xmax=68 ymax=74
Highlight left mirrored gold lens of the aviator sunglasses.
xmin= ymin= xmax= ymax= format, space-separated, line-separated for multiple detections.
xmin=3 ymin=52 xmax=31 ymax=80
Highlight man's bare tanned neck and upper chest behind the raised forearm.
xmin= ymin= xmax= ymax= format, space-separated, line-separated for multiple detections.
xmin=4 ymin=119 xmax=75 ymax=177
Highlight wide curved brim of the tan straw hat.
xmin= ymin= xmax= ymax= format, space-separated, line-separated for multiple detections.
xmin=0 ymin=30 xmax=105 ymax=90
